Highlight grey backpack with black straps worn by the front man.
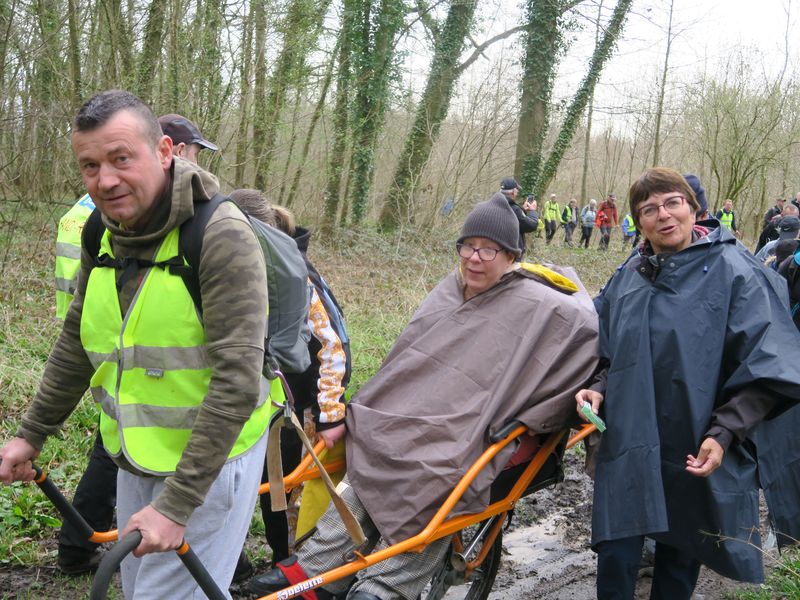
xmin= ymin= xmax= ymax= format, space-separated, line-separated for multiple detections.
xmin=83 ymin=193 xmax=310 ymax=376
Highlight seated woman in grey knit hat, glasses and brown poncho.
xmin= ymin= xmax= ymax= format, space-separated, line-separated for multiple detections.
xmin=251 ymin=194 xmax=597 ymax=600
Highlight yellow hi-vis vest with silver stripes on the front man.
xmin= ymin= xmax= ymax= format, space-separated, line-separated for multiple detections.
xmin=81 ymin=229 xmax=276 ymax=475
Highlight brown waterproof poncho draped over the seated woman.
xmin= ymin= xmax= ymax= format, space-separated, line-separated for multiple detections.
xmin=347 ymin=270 xmax=597 ymax=543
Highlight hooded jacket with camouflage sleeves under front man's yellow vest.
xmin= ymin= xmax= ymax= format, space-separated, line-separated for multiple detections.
xmin=18 ymin=158 xmax=267 ymax=524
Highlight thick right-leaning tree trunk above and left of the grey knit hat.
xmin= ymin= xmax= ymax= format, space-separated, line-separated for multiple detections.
xmin=378 ymin=0 xmax=477 ymax=230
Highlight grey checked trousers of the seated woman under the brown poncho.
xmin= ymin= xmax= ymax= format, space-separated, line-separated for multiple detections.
xmin=297 ymin=477 xmax=450 ymax=600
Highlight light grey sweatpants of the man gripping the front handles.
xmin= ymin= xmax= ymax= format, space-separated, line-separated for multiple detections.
xmin=117 ymin=434 xmax=267 ymax=600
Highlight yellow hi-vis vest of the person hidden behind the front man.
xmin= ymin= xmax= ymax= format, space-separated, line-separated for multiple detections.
xmin=56 ymin=194 xmax=94 ymax=319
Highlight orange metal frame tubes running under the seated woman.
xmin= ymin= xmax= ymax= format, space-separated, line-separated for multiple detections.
xmin=260 ymin=425 xmax=595 ymax=600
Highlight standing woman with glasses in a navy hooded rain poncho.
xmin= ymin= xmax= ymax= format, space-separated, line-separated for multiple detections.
xmin=576 ymin=168 xmax=800 ymax=600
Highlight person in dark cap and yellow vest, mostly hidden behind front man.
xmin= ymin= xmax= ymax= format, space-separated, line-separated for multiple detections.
xmin=55 ymin=113 xmax=218 ymax=575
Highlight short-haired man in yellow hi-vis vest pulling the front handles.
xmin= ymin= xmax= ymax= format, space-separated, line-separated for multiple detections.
xmin=0 ymin=90 xmax=272 ymax=599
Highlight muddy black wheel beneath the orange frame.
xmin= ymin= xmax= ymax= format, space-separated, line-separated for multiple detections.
xmin=420 ymin=521 xmax=503 ymax=600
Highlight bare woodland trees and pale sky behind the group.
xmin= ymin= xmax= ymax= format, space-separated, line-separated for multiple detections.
xmin=0 ymin=0 xmax=800 ymax=237
